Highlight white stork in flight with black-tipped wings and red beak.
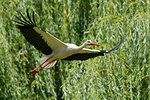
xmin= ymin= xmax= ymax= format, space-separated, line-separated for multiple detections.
xmin=15 ymin=9 xmax=123 ymax=75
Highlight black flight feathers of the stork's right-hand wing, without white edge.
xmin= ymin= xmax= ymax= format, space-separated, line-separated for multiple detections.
xmin=63 ymin=39 xmax=123 ymax=60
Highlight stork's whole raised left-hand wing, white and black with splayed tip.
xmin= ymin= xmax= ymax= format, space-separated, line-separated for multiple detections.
xmin=15 ymin=9 xmax=66 ymax=55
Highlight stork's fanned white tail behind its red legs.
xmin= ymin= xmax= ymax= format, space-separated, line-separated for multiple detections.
xmin=39 ymin=55 xmax=57 ymax=68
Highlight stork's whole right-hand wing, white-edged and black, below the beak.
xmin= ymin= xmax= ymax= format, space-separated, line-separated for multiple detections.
xmin=63 ymin=39 xmax=123 ymax=60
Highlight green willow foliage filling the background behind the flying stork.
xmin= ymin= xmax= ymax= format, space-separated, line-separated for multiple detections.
xmin=0 ymin=0 xmax=150 ymax=100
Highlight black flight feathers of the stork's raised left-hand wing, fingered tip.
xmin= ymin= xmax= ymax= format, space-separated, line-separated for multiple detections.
xmin=14 ymin=9 xmax=52 ymax=55
